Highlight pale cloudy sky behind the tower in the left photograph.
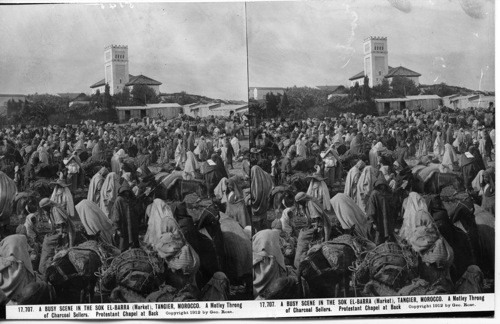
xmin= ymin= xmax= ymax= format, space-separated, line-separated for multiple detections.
xmin=0 ymin=2 xmax=248 ymax=100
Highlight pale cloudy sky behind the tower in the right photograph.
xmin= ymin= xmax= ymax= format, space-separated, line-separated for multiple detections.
xmin=247 ymin=0 xmax=495 ymax=90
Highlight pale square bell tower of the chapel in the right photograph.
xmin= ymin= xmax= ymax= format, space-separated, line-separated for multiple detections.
xmin=363 ymin=36 xmax=389 ymax=87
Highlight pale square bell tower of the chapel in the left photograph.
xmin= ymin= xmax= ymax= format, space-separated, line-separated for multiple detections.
xmin=104 ymin=45 xmax=129 ymax=95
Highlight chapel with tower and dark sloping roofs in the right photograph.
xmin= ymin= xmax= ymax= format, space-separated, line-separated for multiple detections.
xmin=349 ymin=36 xmax=421 ymax=87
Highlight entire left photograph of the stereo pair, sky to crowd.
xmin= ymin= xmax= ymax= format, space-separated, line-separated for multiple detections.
xmin=0 ymin=3 xmax=253 ymax=318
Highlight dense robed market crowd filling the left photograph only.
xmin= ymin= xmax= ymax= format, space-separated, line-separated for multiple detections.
xmin=0 ymin=115 xmax=252 ymax=305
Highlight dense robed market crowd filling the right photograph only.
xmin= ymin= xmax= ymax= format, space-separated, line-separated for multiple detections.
xmin=250 ymin=107 xmax=495 ymax=299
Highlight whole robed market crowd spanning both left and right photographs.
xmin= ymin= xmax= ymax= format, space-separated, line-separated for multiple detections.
xmin=0 ymin=104 xmax=495 ymax=305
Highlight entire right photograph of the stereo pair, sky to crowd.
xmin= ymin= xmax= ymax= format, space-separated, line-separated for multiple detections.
xmin=246 ymin=0 xmax=496 ymax=316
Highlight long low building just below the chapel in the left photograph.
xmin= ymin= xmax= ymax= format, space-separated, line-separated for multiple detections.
xmin=116 ymin=103 xmax=183 ymax=123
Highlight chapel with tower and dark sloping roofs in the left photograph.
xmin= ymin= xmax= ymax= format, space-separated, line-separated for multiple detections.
xmin=90 ymin=45 xmax=162 ymax=95
